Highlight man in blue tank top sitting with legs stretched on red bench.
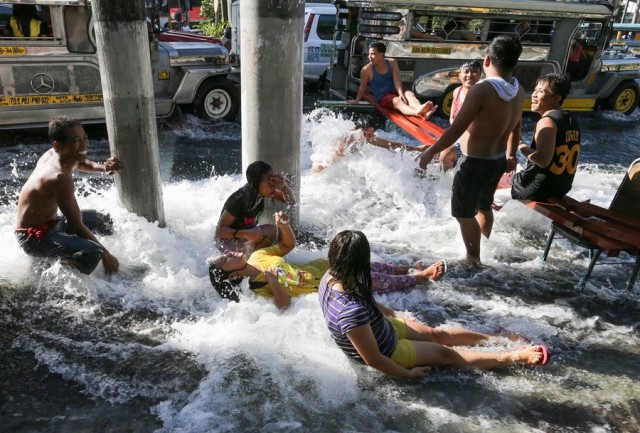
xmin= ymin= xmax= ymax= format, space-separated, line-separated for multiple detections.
xmin=348 ymin=42 xmax=438 ymax=119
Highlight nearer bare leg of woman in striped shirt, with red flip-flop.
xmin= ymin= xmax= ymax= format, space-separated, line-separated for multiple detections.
xmin=412 ymin=341 xmax=542 ymax=368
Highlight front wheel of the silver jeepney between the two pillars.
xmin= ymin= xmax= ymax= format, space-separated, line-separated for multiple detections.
xmin=193 ymin=80 xmax=240 ymax=121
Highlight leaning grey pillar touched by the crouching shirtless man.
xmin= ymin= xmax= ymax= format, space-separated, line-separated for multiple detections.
xmin=91 ymin=0 xmax=165 ymax=227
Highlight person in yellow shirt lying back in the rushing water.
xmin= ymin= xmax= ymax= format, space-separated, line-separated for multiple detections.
xmin=209 ymin=212 xmax=446 ymax=309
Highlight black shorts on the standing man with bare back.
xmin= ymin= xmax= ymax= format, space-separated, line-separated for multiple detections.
xmin=451 ymin=155 xmax=507 ymax=218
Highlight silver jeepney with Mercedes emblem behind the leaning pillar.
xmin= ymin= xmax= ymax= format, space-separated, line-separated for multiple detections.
xmin=0 ymin=0 xmax=239 ymax=129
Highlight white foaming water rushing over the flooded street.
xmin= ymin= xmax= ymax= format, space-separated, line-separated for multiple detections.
xmin=0 ymin=104 xmax=640 ymax=433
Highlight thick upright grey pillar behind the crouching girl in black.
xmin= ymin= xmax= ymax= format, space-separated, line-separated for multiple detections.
xmin=240 ymin=0 xmax=304 ymax=224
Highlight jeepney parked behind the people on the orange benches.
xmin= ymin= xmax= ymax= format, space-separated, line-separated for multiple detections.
xmin=328 ymin=0 xmax=640 ymax=117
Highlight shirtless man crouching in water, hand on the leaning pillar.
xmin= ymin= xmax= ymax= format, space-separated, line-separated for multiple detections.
xmin=15 ymin=116 xmax=120 ymax=274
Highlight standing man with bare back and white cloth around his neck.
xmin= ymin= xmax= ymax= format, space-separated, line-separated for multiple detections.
xmin=418 ymin=35 xmax=524 ymax=264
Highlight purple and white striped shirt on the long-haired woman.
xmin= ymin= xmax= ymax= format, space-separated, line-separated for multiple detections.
xmin=318 ymin=272 xmax=397 ymax=363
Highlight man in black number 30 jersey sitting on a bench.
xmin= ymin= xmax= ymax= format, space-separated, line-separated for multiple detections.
xmin=511 ymin=73 xmax=580 ymax=201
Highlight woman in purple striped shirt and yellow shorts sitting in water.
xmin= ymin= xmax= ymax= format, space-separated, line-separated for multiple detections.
xmin=318 ymin=230 xmax=549 ymax=378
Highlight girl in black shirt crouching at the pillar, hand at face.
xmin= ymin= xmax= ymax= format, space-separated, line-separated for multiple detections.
xmin=215 ymin=161 xmax=296 ymax=252
